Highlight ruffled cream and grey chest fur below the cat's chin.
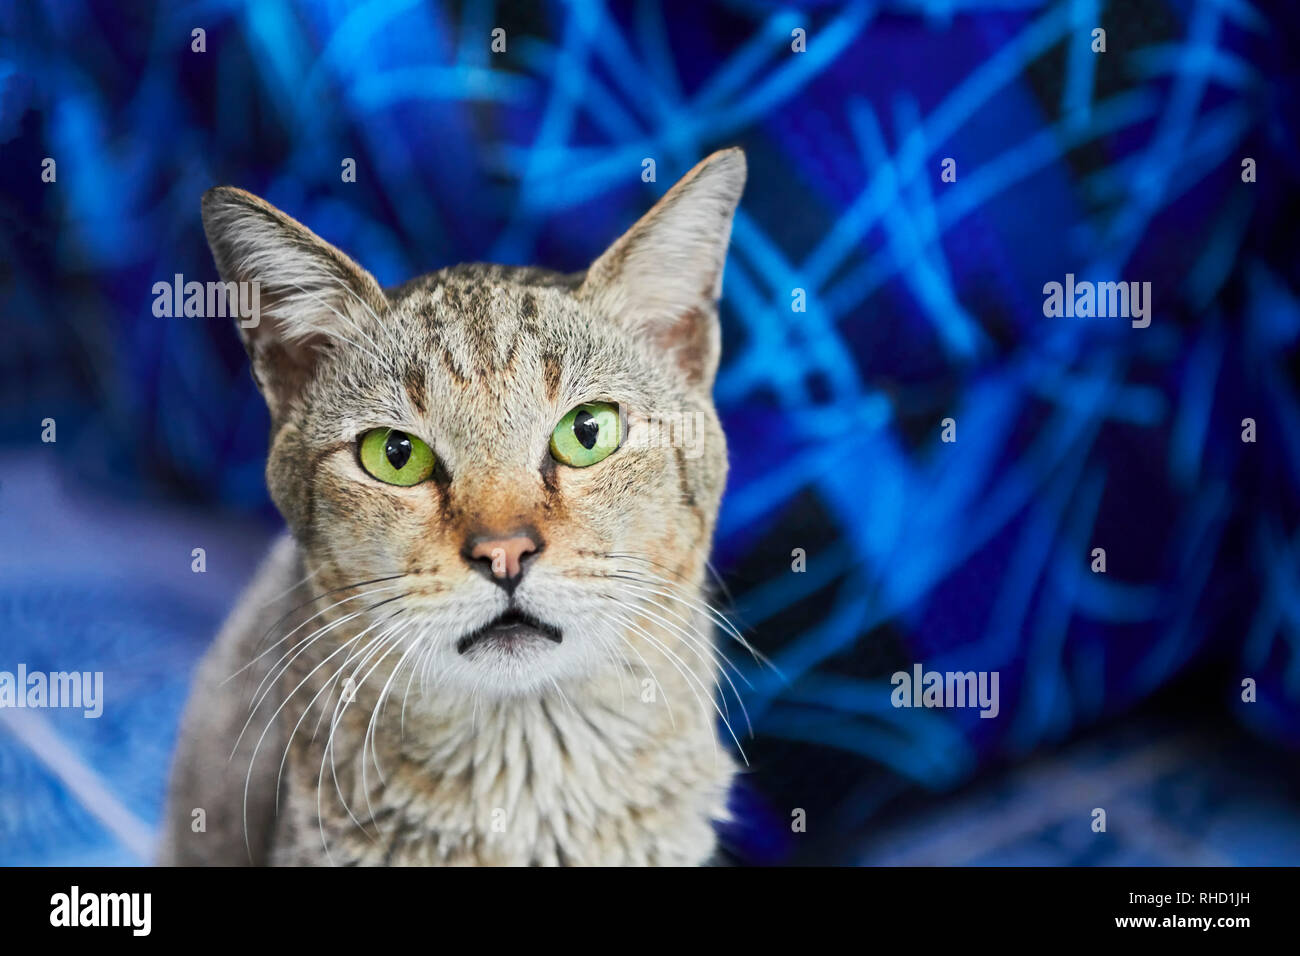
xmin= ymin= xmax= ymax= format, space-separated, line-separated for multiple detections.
xmin=270 ymin=688 xmax=735 ymax=866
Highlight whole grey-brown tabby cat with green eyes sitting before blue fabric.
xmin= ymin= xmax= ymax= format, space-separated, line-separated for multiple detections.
xmin=160 ymin=148 xmax=746 ymax=865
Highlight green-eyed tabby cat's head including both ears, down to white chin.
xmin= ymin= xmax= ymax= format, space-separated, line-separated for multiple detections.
xmin=203 ymin=150 xmax=745 ymax=695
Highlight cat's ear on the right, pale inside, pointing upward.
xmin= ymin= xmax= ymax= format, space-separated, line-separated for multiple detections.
xmin=579 ymin=148 xmax=745 ymax=388
